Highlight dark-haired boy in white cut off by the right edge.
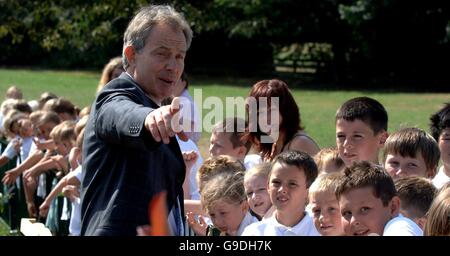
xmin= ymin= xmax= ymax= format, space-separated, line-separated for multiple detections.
xmin=430 ymin=103 xmax=450 ymax=189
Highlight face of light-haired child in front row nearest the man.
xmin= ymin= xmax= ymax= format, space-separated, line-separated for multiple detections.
xmin=207 ymin=199 xmax=248 ymax=235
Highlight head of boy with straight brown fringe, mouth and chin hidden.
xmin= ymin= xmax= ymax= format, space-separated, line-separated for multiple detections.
xmin=383 ymin=127 xmax=440 ymax=179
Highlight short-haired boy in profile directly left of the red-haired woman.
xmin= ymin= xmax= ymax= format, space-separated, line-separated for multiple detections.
xmin=209 ymin=117 xmax=262 ymax=170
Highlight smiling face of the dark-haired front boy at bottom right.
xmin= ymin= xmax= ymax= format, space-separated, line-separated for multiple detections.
xmin=339 ymin=187 xmax=398 ymax=236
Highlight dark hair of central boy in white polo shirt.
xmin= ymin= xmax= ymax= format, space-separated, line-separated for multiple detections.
xmin=269 ymin=150 xmax=319 ymax=188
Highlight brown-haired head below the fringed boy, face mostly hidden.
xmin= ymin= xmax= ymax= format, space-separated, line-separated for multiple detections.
xmin=395 ymin=176 xmax=437 ymax=230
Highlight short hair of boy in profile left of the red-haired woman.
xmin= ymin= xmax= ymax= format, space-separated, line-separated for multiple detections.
xmin=212 ymin=117 xmax=252 ymax=153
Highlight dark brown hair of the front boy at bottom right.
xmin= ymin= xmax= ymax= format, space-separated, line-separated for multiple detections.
xmin=336 ymin=161 xmax=397 ymax=206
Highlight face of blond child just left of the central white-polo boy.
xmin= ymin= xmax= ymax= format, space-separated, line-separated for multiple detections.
xmin=244 ymin=175 xmax=272 ymax=217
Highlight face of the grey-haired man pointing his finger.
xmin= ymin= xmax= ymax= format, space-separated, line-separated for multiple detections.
xmin=129 ymin=23 xmax=187 ymax=104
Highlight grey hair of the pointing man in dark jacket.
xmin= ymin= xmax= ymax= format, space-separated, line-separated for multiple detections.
xmin=122 ymin=5 xmax=192 ymax=70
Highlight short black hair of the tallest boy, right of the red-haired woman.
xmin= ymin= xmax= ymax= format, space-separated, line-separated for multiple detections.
xmin=336 ymin=97 xmax=388 ymax=134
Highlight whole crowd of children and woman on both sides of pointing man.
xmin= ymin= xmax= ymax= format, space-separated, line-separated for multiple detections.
xmin=0 ymin=74 xmax=450 ymax=236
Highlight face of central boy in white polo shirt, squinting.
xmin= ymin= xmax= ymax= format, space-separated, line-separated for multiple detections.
xmin=268 ymin=163 xmax=308 ymax=215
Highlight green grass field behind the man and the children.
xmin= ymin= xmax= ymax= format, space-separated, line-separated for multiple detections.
xmin=0 ymin=69 xmax=450 ymax=156
